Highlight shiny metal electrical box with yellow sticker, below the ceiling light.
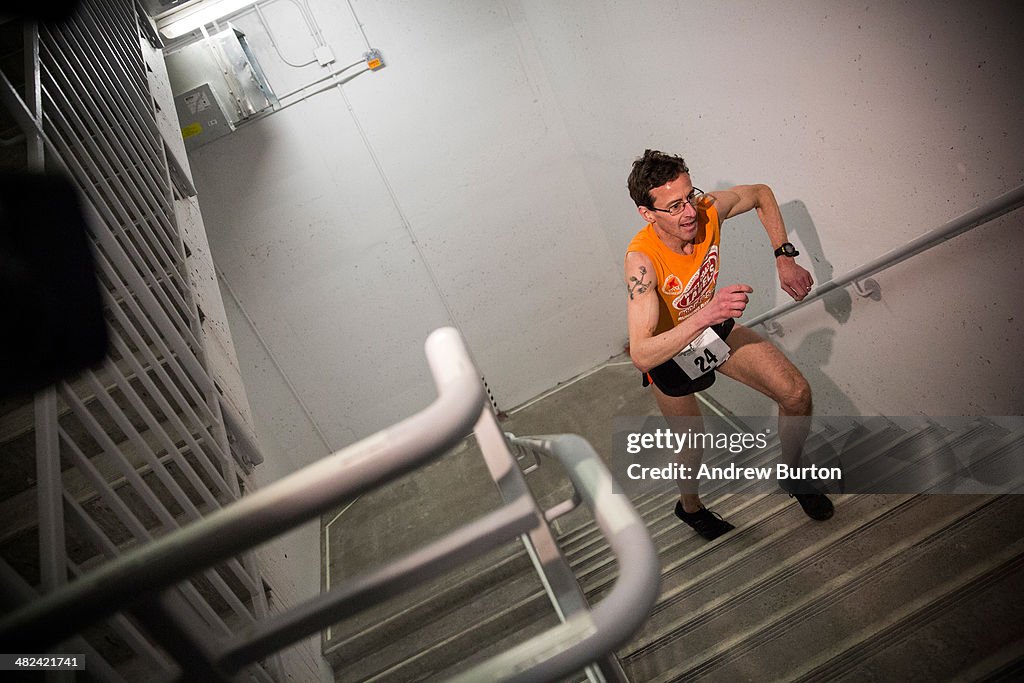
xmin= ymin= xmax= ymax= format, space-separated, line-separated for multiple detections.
xmin=166 ymin=26 xmax=279 ymax=150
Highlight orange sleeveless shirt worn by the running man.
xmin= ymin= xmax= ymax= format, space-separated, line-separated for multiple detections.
xmin=626 ymin=205 xmax=721 ymax=335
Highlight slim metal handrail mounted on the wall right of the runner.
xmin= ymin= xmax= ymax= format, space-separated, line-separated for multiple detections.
xmin=743 ymin=185 xmax=1024 ymax=328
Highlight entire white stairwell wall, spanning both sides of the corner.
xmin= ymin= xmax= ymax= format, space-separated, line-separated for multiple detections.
xmin=184 ymin=0 xmax=1024 ymax=483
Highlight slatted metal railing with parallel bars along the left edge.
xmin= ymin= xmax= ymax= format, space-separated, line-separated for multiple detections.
xmin=0 ymin=0 xmax=282 ymax=681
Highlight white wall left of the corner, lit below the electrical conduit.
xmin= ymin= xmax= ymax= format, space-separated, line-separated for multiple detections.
xmin=191 ymin=2 xmax=625 ymax=458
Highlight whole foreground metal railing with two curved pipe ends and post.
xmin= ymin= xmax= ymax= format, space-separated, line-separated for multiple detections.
xmin=0 ymin=328 xmax=660 ymax=681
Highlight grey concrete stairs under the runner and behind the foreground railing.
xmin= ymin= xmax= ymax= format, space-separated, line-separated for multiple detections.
xmin=323 ymin=421 xmax=1024 ymax=681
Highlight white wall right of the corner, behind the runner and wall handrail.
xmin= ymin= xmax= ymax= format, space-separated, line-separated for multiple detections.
xmin=516 ymin=1 xmax=1024 ymax=415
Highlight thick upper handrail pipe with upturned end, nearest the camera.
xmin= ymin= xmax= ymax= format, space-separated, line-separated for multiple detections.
xmin=0 ymin=328 xmax=485 ymax=652
